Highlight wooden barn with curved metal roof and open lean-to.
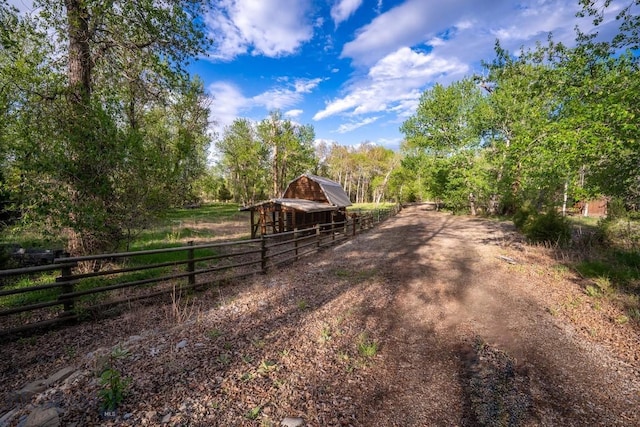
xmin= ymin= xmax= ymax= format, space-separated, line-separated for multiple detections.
xmin=240 ymin=174 xmax=351 ymax=239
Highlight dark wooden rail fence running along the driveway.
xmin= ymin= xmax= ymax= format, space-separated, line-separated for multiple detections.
xmin=0 ymin=207 xmax=399 ymax=336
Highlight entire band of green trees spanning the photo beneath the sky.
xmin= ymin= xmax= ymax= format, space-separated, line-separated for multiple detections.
xmin=0 ymin=0 xmax=640 ymax=253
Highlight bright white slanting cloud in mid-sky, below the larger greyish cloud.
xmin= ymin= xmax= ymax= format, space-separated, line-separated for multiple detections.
xmin=313 ymin=47 xmax=468 ymax=120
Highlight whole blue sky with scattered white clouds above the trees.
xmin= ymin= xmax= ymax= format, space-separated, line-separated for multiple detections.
xmin=10 ymin=0 xmax=624 ymax=149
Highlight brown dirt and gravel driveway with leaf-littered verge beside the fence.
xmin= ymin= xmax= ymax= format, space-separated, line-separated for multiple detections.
xmin=0 ymin=206 xmax=640 ymax=426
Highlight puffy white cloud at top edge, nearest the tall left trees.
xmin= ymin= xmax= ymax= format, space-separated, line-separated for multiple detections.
xmin=204 ymin=0 xmax=313 ymax=60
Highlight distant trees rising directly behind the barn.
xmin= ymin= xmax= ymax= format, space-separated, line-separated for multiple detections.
xmin=209 ymin=111 xmax=399 ymax=205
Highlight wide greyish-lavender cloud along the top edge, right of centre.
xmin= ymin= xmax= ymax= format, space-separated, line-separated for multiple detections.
xmin=341 ymin=0 xmax=579 ymax=67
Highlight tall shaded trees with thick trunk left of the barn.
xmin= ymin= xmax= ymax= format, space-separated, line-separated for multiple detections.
xmin=0 ymin=0 xmax=210 ymax=253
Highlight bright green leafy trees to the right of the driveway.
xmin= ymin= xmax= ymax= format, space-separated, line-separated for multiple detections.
xmin=401 ymin=0 xmax=640 ymax=214
